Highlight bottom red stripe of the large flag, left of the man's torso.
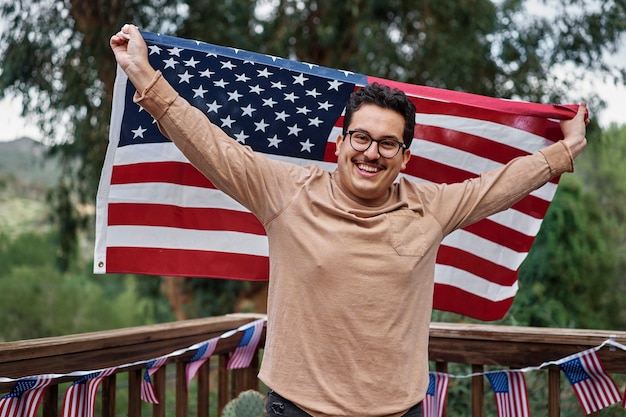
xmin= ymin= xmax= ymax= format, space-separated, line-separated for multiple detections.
xmin=106 ymin=246 xmax=269 ymax=281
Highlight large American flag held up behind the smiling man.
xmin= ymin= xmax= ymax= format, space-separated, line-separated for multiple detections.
xmin=94 ymin=32 xmax=576 ymax=320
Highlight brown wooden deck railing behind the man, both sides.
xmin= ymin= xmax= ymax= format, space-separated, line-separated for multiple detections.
xmin=0 ymin=315 xmax=626 ymax=417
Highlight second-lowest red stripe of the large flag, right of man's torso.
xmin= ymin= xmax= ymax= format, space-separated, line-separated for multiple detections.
xmin=437 ymin=245 xmax=517 ymax=286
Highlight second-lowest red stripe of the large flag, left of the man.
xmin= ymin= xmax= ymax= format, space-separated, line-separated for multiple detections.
xmin=108 ymin=203 xmax=265 ymax=235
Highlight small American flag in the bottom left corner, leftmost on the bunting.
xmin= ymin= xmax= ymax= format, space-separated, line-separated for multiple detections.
xmin=0 ymin=375 xmax=53 ymax=417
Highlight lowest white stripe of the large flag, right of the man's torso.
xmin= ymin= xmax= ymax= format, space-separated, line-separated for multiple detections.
xmin=435 ymin=264 xmax=518 ymax=302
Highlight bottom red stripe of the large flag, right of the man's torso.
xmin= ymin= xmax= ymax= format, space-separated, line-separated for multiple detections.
xmin=433 ymin=283 xmax=513 ymax=321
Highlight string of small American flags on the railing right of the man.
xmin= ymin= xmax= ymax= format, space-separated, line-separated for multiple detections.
xmin=423 ymin=338 xmax=626 ymax=417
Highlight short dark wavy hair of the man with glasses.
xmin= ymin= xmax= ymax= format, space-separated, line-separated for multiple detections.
xmin=343 ymin=83 xmax=415 ymax=148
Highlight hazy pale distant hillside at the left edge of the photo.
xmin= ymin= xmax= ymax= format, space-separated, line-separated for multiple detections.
xmin=0 ymin=138 xmax=59 ymax=235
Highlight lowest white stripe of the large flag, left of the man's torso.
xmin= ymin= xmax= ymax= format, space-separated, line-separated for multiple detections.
xmin=107 ymin=226 xmax=269 ymax=256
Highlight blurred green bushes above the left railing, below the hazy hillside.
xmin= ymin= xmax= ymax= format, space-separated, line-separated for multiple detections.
xmin=0 ymin=233 xmax=158 ymax=341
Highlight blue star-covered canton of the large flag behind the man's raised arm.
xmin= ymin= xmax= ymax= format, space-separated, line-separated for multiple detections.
xmin=120 ymin=33 xmax=366 ymax=161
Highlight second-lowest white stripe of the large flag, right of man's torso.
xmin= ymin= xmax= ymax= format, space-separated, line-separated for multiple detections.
xmin=441 ymin=229 xmax=528 ymax=271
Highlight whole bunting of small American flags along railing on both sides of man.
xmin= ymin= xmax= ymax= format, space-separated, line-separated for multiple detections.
xmin=0 ymin=324 xmax=626 ymax=417
